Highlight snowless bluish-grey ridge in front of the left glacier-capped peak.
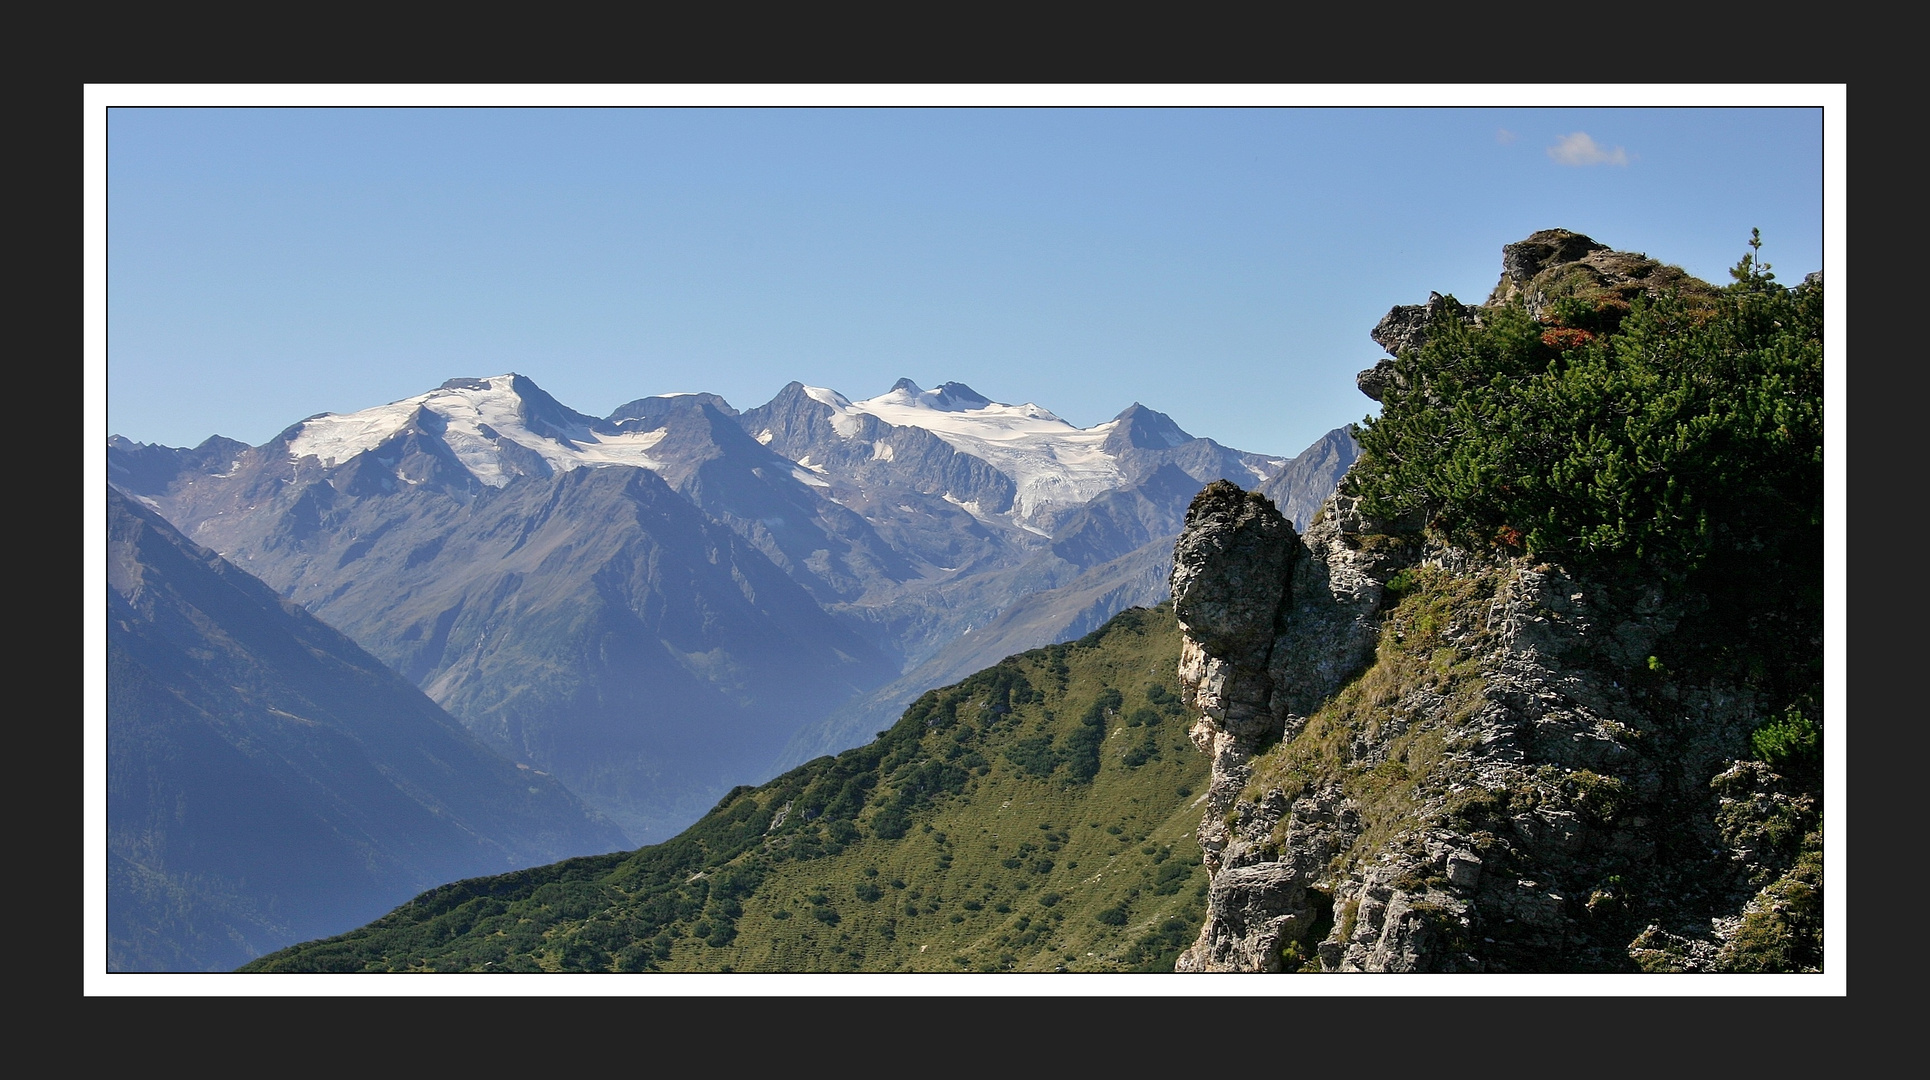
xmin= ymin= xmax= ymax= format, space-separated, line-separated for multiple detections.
xmin=264 ymin=469 xmax=890 ymax=841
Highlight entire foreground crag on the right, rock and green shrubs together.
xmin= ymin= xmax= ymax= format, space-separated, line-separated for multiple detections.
xmin=1173 ymin=230 xmax=1830 ymax=972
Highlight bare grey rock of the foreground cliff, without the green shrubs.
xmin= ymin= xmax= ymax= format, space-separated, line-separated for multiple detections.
xmin=1172 ymin=230 xmax=1822 ymax=972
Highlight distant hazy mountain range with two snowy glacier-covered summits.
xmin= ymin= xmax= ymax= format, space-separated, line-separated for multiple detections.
xmin=108 ymin=374 xmax=1357 ymax=843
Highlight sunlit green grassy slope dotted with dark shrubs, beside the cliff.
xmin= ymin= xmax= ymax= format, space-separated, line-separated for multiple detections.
xmin=243 ymin=606 xmax=1208 ymax=972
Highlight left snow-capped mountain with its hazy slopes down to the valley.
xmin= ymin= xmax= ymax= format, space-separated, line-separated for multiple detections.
xmin=110 ymin=376 xmax=894 ymax=841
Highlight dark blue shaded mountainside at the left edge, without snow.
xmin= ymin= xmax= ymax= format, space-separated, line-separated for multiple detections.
xmin=108 ymin=488 xmax=623 ymax=970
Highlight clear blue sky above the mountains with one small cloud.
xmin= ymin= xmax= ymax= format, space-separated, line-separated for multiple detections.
xmin=106 ymin=93 xmax=1826 ymax=453
